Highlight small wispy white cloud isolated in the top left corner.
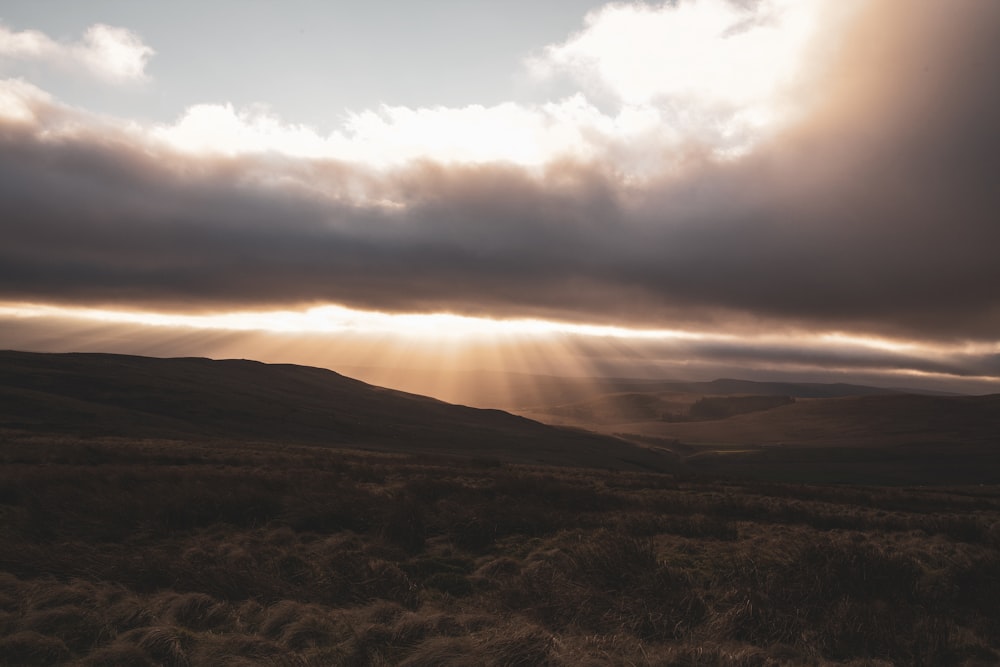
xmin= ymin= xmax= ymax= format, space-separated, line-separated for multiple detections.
xmin=0 ymin=23 xmax=155 ymax=83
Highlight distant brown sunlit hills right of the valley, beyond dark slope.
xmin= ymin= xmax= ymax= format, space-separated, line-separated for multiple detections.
xmin=522 ymin=385 xmax=1000 ymax=484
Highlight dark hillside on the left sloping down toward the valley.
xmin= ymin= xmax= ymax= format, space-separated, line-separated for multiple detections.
xmin=0 ymin=351 xmax=668 ymax=469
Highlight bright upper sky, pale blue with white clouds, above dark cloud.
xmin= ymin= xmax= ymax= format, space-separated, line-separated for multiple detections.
xmin=0 ymin=0 xmax=818 ymax=175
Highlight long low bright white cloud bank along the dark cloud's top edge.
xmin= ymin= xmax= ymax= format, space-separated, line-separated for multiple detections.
xmin=153 ymin=96 xmax=613 ymax=167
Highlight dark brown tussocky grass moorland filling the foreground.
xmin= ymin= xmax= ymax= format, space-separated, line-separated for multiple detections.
xmin=0 ymin=431 xmax=1000 ymax=667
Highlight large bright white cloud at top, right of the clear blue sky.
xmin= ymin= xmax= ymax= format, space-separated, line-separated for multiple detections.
xmin=529 ymin=0 xmax=816 ymax=105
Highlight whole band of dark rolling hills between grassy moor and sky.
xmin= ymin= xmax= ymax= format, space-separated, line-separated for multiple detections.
xmin=0 ymin=351 xmax=1000 ymax=483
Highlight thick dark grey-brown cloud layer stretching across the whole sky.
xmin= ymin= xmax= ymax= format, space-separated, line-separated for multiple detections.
xmin=0 ymin=0 xmax=1000 ymax=340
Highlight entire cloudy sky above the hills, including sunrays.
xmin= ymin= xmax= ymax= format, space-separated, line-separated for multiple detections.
xmin=0 ymin=0 xmax=1000 ymax=397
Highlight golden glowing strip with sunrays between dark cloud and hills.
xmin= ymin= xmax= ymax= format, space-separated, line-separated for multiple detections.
xmin=0 ymin=302 xmax=1000 ymax=400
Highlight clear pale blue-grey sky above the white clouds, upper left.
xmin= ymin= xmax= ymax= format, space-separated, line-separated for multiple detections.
xmin=0 ymin=0 xmax=602 ymax=125
